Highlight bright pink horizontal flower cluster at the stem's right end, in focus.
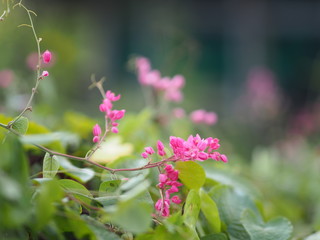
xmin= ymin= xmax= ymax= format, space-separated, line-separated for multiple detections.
xmin=170 ymin=134 xmax=228 ymax=162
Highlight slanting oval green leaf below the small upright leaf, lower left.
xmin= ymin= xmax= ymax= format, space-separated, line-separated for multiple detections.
xmin=58 ymin=179 xmax=93 ymax=205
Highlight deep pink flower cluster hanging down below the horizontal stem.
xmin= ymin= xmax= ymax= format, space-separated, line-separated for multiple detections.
xmin=155 ymin=164 xmax=182 ymax=217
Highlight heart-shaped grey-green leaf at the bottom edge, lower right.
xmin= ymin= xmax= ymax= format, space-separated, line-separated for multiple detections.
xmin=241 ymin=209 xmax=293 ymax=240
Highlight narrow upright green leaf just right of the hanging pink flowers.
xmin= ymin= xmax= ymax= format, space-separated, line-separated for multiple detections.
xmin=183 ymin=189 xmax=201 ymax=229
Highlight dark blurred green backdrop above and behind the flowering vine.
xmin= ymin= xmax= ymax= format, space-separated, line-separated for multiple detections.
xmin=0 ymin=0 xmax=320 ymax=156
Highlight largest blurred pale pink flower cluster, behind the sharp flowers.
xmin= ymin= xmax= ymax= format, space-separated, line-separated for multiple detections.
xmin=136 ymin=57 xmax=185 ymax=102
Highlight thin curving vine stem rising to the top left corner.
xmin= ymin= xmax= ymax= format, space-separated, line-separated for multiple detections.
xmin=8 ymin=1 xmax=42 ymax=127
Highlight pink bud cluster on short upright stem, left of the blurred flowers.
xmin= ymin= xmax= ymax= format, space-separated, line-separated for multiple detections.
xmin=93 ymin=90 xmax=126 ymax=143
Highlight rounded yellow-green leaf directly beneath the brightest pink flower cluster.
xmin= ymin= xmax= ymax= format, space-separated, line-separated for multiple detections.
xmin=175 ymin=161 xmax=206 ymax=189
